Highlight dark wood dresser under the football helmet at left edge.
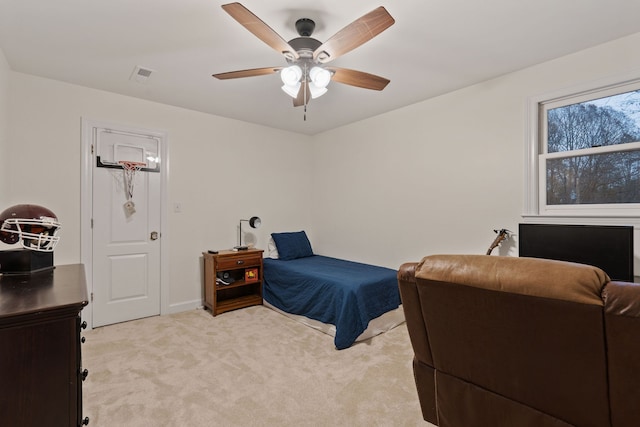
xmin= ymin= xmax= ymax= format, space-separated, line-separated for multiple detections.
xmin=0 ymin=264 xmax=89 ymax=427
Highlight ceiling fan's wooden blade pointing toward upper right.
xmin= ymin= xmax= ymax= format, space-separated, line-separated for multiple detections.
xmin=313 ymin=6 xmax=396 ymax=63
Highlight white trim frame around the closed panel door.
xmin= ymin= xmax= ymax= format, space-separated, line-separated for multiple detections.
xmin=80 ymin=117 xmax=170 ymax=329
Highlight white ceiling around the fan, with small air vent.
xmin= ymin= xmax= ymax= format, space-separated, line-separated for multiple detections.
xmin=0 ymin=0 xmax=640 ymax=135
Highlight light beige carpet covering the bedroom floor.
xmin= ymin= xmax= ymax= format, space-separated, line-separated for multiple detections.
xmin=82 ymin=306 xmax=431 ymax=427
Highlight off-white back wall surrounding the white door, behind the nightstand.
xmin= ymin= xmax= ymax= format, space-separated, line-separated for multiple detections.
xmin=5 ymin=73 xmax=312 ymax=307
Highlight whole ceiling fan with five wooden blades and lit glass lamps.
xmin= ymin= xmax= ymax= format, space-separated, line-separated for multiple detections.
xmin=213 ymin=3 xmax=395 ymax=111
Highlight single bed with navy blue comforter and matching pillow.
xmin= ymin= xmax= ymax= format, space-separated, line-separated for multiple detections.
xmin=263 ymin=231 xmax=404 ymax=350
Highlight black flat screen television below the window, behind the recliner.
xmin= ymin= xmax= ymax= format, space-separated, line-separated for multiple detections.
xmin=518 ymin=224 xmax=633 ymax=282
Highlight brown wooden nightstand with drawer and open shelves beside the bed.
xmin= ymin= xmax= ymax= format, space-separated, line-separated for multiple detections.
xmin=202 ymin=249 xmax=264 ymax=316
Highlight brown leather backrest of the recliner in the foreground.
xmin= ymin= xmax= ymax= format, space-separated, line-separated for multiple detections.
xmin=412 ymin=255 xmax=610 ymax=426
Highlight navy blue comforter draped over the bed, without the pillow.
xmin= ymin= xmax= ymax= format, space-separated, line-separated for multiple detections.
xmin=264 ymin=255 xmax=400 ymax=350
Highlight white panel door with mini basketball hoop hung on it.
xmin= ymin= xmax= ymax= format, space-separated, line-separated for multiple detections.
xmin=92 ymin=128 xmax=162 ymax=327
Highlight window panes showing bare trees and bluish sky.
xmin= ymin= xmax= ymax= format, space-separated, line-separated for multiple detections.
xmin=540 ymin=90 xmax=640 ymax=206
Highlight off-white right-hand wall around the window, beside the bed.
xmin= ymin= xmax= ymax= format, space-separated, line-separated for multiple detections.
xmin=313 ymin=34 xmax=640 ymax=268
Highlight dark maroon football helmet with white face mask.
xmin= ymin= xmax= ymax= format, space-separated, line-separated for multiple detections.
xmin=0 ymin=205 xmax=62 ymax=252
